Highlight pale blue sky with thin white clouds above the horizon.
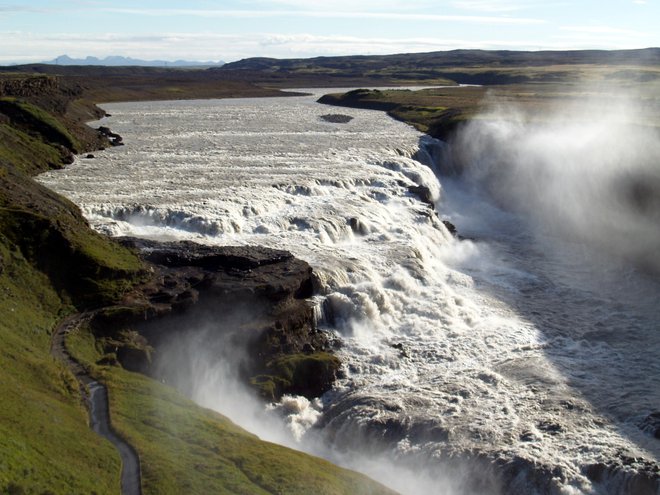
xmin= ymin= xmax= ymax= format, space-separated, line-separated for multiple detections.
xmin=0 ymin=0 xmax=660 ymax=64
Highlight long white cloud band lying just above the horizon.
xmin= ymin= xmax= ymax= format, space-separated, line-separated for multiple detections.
xmin=0 ymin=32 xmax=636 ymax=64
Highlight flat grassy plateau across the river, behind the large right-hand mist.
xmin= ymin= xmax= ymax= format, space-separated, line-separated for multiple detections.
xmin=319 ymin=67 xmax=660 ymax=138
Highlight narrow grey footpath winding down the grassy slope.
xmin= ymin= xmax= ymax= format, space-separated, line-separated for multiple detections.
xmin=50 ymin=313 xmax=142 ymax=495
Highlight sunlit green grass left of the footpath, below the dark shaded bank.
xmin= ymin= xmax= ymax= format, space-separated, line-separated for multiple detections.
xmin=0 ymin=235 xmax=120 ymax=494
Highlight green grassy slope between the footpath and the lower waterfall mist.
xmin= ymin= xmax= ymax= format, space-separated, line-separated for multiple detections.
xmin=68 ymin=328 xmax=393 ymax=495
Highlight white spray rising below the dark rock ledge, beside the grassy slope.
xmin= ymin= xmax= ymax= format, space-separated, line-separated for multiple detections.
xmin=153 ymin=318 xmax=500 ymax=495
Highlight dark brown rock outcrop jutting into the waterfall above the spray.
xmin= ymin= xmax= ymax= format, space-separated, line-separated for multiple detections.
xmin=94 ymin=238 xmax=339 ymax=400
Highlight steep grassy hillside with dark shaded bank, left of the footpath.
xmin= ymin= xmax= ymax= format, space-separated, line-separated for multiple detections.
xmin=0 ymin=75 xmax=142 ymax=494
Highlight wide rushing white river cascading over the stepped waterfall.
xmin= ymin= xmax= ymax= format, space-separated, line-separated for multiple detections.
xmin=40 ymin=91 xmax=660 ymax=494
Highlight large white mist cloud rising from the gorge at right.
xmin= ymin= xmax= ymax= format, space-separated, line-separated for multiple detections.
xmin=445 ymin=88 xmax=660 ymax=274
